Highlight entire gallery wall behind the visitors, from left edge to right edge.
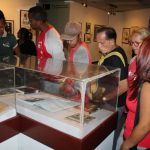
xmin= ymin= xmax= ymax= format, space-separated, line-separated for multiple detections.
xmin=0 ymin=0 xmax=150 ymax=61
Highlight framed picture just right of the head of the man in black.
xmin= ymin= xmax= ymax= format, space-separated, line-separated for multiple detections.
xmin=122 ymin=28 xmax=130 ymax=44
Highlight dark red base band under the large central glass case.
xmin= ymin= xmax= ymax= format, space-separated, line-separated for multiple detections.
xmin=20 ymin=113 xmax=117 ymax=150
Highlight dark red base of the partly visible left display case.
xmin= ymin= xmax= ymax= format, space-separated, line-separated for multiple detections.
xmin=0 ymin=115 xmax=20 ymax=142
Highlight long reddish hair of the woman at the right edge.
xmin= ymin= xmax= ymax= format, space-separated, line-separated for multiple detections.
xmin=131 ymin=36 xmax=150 ymax=99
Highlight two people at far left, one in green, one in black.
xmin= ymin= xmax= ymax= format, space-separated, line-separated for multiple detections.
xmin=0 ymin=10 xmax=36 ymax=64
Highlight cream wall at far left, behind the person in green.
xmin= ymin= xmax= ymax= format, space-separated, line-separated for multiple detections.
xmin=0 ymin=0 xmax=38 ymax=35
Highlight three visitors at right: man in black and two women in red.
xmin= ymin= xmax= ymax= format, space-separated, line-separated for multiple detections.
xmin=97 ymin=27 xmax=150 ymax=150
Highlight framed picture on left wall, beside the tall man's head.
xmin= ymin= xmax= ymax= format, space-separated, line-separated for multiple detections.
xmin=20 ymin=10 xmax=31 ymax=29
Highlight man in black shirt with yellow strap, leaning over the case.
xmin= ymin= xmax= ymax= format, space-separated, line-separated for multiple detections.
xmin=97 ymin=27 xmax=128 ymax=150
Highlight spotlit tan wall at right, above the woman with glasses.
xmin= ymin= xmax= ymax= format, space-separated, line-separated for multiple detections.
xmin=110 ymin=9 xmax=150 ymax=60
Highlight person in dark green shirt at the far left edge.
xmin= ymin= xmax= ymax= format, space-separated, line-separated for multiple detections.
xmin=0 ymin=10 xmax=19 ymax=65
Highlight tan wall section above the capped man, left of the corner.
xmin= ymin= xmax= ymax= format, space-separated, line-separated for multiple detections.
xmin=69 ymin=2 xmax=108 ymax=61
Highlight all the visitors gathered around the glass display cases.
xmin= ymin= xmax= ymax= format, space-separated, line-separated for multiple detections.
xmin=0 ymin=6 xmax=150 ymax=150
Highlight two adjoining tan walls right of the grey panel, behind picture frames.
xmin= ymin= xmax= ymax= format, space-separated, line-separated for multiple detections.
xmin=70 ymin=2 xmax=150 ymax=61
